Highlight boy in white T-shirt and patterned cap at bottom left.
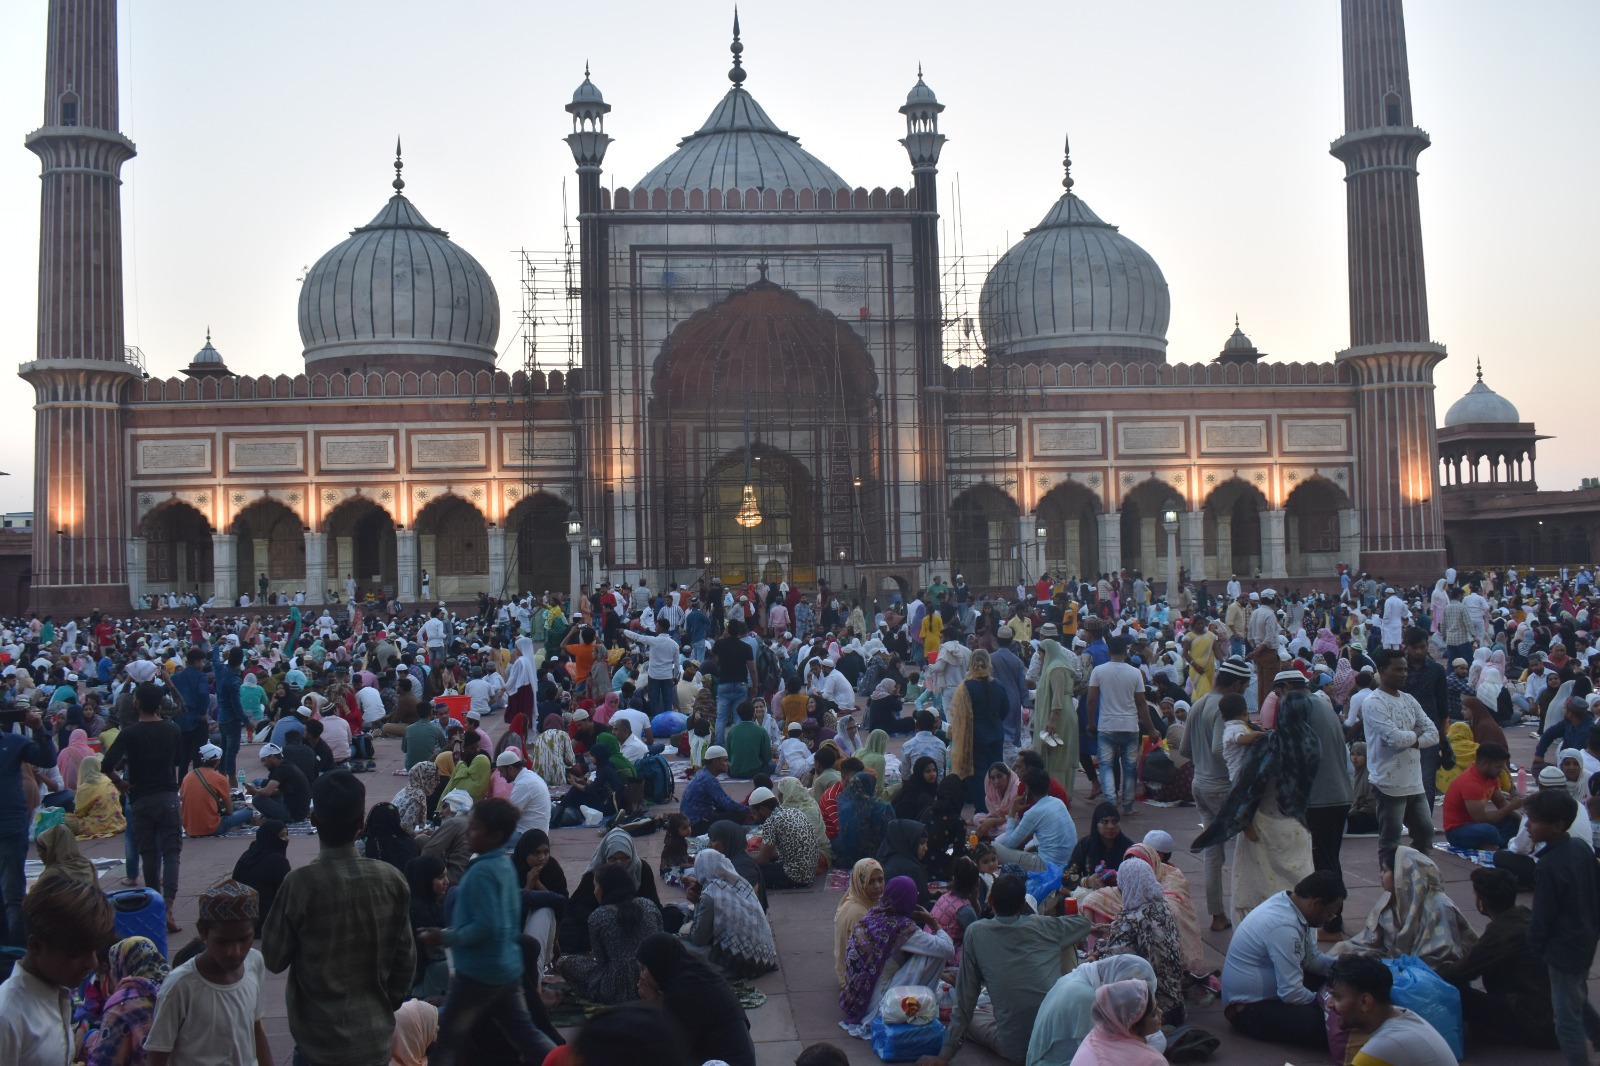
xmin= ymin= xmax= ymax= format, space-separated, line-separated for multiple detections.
xmin=144 ymin=879 xmax=272 ymax=1066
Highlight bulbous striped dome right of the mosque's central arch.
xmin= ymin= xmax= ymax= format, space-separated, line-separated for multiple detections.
xmin=979 ymin=192 xmax=1171 ymax=363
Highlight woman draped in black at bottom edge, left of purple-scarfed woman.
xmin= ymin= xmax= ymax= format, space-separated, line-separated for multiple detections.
xmin=638 ymin=933 xmax=755 ymax=1066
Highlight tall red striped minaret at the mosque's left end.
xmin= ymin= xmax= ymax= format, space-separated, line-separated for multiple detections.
xmin=19 ymin=0 xmax=141 ymax=611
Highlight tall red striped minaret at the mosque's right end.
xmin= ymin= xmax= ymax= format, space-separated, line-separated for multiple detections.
xmin=1331 ymin=0 xmax=1445 ymax=581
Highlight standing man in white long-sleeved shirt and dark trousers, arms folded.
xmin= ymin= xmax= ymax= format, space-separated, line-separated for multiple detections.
xmin=1362 ymin=648 xmax=1438 ymax=863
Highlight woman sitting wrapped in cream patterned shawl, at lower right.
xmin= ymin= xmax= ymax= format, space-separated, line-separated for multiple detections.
xmin=1330 ymin=845 xmax=1478 ymax=970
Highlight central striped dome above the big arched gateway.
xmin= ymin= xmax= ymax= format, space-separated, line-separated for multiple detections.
xmin=632 ymin=85 xmax=851 ymax=192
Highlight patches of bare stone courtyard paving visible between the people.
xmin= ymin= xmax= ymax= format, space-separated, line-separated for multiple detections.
xmin=65 ymin=704 xmax=1600 ymax=1066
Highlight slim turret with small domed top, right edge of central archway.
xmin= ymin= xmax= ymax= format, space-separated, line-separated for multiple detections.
xmin=901 ymin=64 xmax=950 ymax=578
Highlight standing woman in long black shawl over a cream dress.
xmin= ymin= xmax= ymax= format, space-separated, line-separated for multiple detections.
xmin=1190 ymin=691 xmax=1323 ymax=922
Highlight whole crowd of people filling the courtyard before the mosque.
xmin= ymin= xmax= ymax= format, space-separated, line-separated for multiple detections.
xmin=0 ymin=570 xmax=1600 ymax=1066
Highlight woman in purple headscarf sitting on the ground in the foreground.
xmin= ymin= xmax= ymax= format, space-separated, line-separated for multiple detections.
xmin=838 ymin=877 xmax=955 ymax=1036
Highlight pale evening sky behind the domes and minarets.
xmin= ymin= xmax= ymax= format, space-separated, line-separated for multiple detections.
xmin=0 ymin=0 xmax=1600 ymax=511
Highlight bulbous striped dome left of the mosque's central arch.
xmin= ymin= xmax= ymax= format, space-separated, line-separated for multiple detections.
xmin=299 ymin=192 xmax=499 ymax=370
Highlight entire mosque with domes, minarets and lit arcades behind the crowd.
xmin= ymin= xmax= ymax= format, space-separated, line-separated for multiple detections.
xmin=21 ymin=0 xmax=1600 ymax=611
